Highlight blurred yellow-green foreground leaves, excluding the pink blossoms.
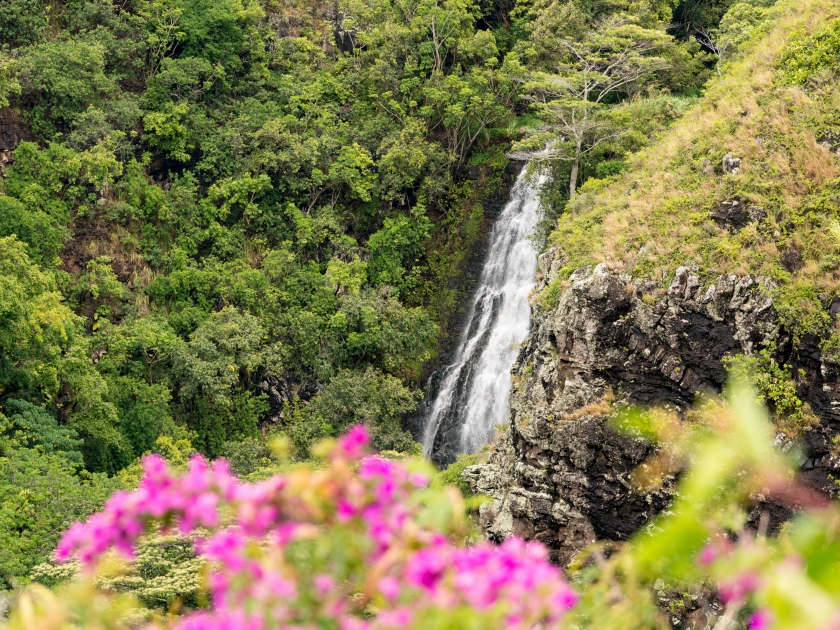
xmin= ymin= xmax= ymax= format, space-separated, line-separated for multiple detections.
xmin=4 ymin=384 xmax=840 ymax=630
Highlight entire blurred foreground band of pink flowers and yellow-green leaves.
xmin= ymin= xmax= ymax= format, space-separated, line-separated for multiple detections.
xmin=9 ymin=383 xmax=840 ymax=630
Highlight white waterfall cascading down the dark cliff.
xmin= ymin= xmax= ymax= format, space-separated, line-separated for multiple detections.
xmin=423 ymin=169 xmax=541 ymax=456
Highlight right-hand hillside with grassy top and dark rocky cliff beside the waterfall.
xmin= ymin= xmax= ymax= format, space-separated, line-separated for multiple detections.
xmin=464 ymin=0 xmax=840 ymax=592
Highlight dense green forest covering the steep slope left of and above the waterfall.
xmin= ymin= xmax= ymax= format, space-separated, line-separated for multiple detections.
xmin=0 ymin=0 xmax=808 ymax=604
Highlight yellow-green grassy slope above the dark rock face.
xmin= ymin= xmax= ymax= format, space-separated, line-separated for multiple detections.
xmin=545 ymin=0 xmax=840 ymax=340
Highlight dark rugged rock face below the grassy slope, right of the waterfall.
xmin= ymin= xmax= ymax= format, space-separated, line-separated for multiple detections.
xmin=465 ymin=262 xmax=840 ymax=564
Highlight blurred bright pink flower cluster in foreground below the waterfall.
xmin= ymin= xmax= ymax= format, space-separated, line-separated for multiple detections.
xmin=29 ymin=427 xmax=576 ymax=630
